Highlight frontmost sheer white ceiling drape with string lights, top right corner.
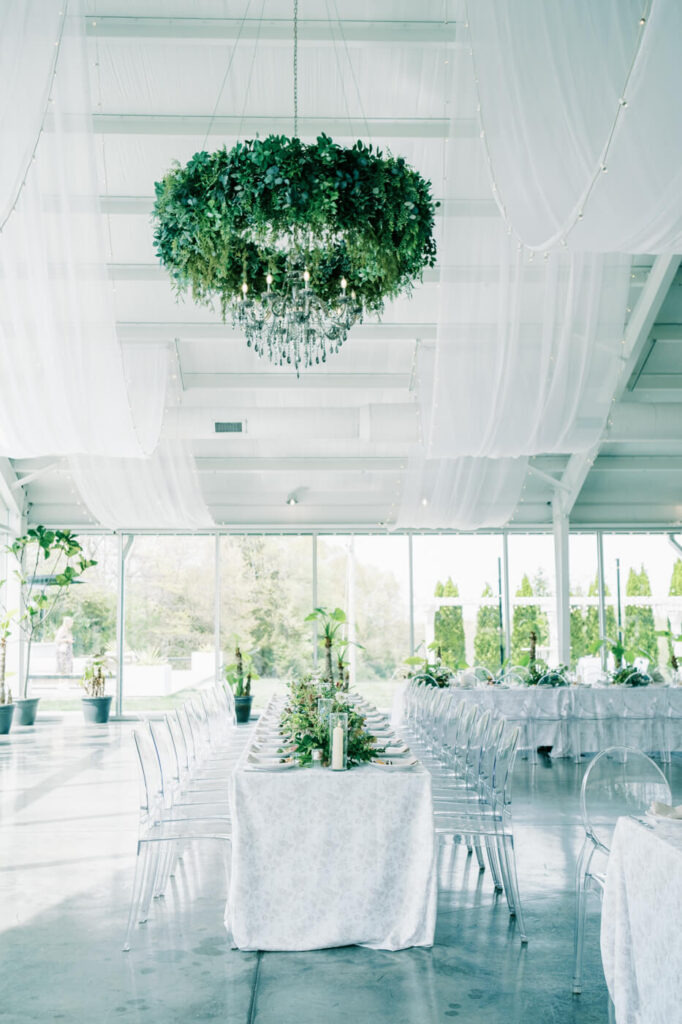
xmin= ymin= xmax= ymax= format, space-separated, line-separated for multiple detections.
xmin=467 ymin=0 xmax=682 ymax=253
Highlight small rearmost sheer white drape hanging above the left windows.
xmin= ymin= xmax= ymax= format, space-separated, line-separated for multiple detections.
xmin=69 ymin=438 xmax=214 ymax=529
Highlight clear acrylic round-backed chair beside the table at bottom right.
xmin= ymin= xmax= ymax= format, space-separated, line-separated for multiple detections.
xmin=573 ymin=746 xmax=671 ymax=994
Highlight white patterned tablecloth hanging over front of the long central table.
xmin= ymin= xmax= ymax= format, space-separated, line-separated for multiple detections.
xmin=225 ymin=741 xmax=436 ymax=949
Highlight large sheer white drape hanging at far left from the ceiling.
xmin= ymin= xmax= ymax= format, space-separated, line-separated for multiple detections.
xmin=0 ymin=0 xmax=167 ymax=458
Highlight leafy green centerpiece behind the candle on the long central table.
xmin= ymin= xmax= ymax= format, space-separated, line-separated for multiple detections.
xmin=280 ymin=680 xmax=384 ymax=766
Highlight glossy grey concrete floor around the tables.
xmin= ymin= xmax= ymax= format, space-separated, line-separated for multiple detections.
xmin=0 ymin=716 xmax=671 ymax=1024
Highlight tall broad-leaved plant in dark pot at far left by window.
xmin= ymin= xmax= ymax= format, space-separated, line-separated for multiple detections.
xmin=3 ymin=526 xmax=97 ymax=725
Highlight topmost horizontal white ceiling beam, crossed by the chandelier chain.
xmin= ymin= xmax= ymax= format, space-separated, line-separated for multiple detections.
xmin=86 ymin=15 xmax=458 ymax=46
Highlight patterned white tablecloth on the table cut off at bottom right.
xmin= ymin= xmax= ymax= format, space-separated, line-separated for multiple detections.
xmin=601 ymin=818 xmax=682 ymax=1024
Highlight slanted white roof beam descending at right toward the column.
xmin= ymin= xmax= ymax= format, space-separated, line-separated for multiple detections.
xmin=557 ymin=256 xmax=680 ymax=515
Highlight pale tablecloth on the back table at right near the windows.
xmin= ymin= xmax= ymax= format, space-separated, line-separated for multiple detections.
xmin=393 ymin=686 xmax=682 ymax=757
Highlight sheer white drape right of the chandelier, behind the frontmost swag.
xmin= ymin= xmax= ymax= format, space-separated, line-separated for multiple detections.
xmin=425 ymin=232 xmax=631 ymax=459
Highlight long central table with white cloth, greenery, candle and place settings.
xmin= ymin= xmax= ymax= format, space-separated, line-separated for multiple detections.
xmin=225 ymin=682 xmax=436 ymax=950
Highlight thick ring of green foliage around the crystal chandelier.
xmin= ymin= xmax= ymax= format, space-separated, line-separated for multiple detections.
xmin=154 ymin=135 xmax=438 ymax=317
